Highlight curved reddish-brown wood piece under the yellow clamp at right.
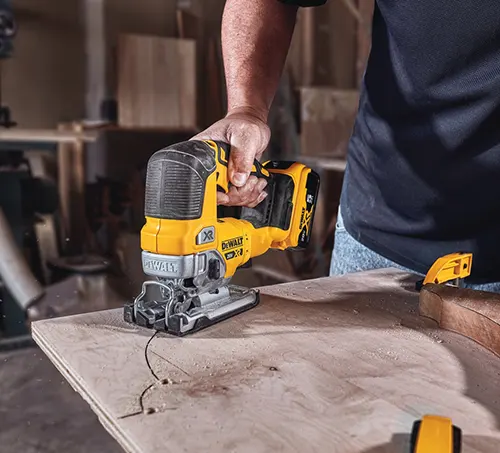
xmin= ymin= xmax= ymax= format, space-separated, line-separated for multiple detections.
xmin=419 ymin=284 xmax=500 ymax=357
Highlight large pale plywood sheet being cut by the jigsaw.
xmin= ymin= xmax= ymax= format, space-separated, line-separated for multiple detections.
xmin=33 ymin=270 xmax=500 ymax=453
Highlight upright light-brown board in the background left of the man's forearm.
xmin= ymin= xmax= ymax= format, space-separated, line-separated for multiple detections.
xmin=118 ymin=35 xmax=197 ymax=130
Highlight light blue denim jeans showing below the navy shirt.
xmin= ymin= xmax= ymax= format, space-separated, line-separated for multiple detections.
xmin=330 ymin=210 xmax=500 ymax=293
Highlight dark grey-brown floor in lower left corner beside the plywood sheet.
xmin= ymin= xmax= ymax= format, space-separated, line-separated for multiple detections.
xmin=0 ymin=347 xmax=123 ymax=453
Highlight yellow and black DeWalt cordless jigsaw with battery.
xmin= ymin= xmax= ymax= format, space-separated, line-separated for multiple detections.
xmin=124 ymin=140 xmax=320 ymax=336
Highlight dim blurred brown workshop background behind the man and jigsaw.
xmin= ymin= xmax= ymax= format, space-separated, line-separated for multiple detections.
xmin=0 ymin=0 xmax=373 ymax=453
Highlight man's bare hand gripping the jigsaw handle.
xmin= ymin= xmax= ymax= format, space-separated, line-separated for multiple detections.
xmin=192 ymin=108 xmax=271 ymax=208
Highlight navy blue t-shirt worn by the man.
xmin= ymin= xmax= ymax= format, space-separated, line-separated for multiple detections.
xmin=282 ymin=0 xmax=500 ymax=281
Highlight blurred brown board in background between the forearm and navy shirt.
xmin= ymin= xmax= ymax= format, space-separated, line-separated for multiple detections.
xmin=300 ymin=87 xmax=359 ymax=157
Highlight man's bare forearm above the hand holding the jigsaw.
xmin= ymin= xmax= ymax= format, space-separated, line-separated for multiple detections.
xmin=222 ymin=0 xmax=297 ymax=121
